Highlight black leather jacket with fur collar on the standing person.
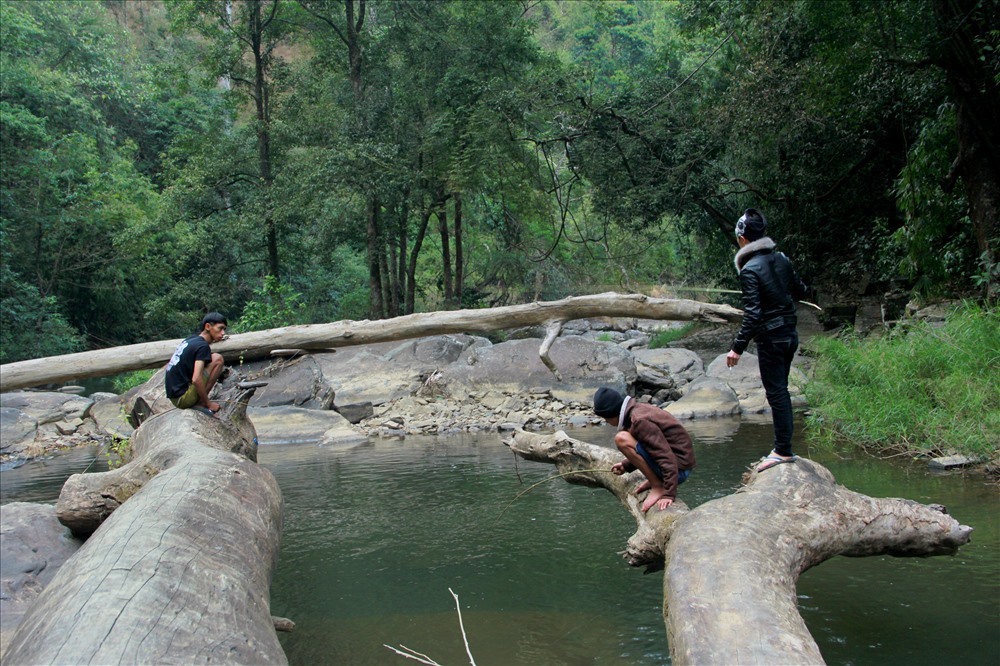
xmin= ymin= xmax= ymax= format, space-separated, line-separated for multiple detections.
xmin=732 ymin=236 xmax=809 ymax=354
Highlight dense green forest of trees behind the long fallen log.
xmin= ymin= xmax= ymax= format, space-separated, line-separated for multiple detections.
xmin=0 ymin=0 xmax=1000 ymax=362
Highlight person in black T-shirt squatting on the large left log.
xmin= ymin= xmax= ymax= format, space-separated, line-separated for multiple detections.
xmin=164 ymin=312 xmax=229 ymax=414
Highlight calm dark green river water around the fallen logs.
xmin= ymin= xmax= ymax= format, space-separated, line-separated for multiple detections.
xmin=0 ymin=419 xmax=1000 ymax=666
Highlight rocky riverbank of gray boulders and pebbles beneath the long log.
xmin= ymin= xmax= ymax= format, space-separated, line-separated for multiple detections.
xmin=0 ymin=319 xmax=805 ymax=465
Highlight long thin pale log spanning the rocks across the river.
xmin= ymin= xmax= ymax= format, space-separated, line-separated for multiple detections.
xmin=0 ymin=293 xmax=742 ymax=391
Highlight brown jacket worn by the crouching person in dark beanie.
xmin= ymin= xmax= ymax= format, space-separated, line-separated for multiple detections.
xmin=622 ymin=400 xmax=696 ymax=499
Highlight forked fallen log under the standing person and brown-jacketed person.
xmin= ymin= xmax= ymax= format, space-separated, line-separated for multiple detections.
xmin=507 ymin=431 xmax=972 ymax=666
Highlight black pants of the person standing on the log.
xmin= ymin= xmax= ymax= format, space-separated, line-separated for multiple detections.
xmin=757 ymin=326 xmax=799 ymax=456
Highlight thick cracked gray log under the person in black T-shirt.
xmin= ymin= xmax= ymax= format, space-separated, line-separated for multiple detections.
xmin=4 ymin=376 xmax=289 ymax=666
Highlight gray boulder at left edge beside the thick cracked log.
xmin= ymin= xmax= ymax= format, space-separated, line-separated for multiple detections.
xmin=0 ymin=502 xmax=83 ymax=655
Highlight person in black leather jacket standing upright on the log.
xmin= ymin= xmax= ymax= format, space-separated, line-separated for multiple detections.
xmin=726 ymin=208 xmax=809 ymax=472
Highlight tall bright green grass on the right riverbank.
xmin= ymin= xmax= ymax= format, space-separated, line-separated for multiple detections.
xmin=805 ymin=304 xmax=1000 ymax=458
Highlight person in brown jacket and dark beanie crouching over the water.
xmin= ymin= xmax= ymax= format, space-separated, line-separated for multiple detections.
xmin=594 ymin=386 xmax=695 ymax=512
